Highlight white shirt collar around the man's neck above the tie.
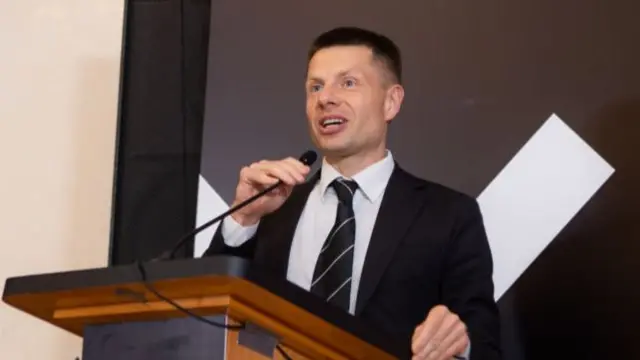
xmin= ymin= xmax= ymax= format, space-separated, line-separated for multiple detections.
xmin=319 ymin=150 xmax=395 ymax=202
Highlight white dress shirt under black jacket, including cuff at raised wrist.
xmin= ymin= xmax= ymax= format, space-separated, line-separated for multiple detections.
xmin=222 ymin=151 xmax=395 ymax=314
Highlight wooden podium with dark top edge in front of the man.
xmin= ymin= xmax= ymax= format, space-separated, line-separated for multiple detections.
xmin=3 ymin=256 xmax=406 ymax=360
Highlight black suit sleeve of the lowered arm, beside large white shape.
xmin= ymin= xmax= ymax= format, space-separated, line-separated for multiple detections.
xmin=442 ymin=199 xmax=501 ymax=360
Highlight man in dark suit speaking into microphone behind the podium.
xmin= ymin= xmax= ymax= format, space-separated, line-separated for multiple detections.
xmin=205 ymin=27 xmax=500 ymax=360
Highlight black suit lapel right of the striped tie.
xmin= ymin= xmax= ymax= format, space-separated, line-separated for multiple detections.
xmin=355 ymin=164 xmax=425 ymax=315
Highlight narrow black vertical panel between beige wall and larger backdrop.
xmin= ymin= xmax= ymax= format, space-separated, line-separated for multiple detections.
xmin=110 ymin=0 xmax=210 ymax=264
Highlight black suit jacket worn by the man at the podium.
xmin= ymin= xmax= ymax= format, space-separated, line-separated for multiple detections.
xmin=205 ymin=164 xmax=500 ymax=360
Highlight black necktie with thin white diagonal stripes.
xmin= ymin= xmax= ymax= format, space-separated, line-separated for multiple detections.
xmin=311 ymin=178 xmax=358 ymax=312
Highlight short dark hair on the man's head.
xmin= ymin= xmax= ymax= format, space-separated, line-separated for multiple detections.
xmin=307 ymin=26 xmax=402 ymax=83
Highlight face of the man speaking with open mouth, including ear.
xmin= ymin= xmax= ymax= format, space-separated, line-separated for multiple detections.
xmin=306 ymin=46 xmax=402 ymax=157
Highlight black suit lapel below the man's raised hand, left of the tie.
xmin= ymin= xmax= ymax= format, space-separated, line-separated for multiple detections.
xmin=269 ymin=171 xmax=320 ymax=277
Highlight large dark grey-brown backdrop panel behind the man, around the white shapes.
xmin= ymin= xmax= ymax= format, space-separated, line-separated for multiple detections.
xmin=201 ymin=0 xmax=640 ymax=359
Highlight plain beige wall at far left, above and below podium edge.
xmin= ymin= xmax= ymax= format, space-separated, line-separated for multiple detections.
xmin=0 ymin=0 xmax=124 ymax=360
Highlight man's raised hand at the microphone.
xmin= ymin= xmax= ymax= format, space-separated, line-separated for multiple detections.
xmin=231 ymin=157 xmax=310 ymax=226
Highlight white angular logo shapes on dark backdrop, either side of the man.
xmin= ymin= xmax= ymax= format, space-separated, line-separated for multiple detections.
xmin=194 ymin=114 xmax=614 ymax=299
